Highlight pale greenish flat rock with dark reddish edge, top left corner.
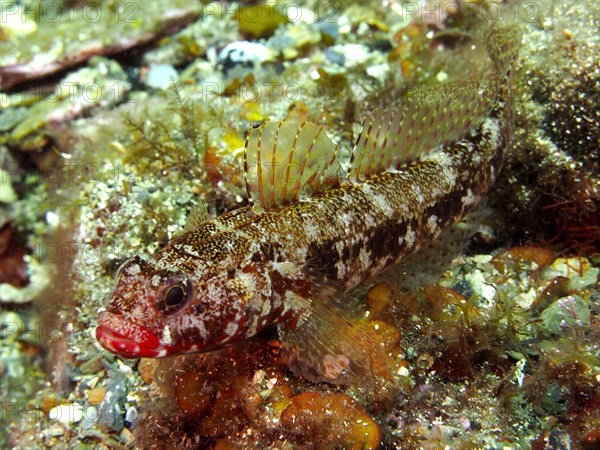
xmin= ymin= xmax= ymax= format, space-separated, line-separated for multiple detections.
xmin=0 ymin=0 xmax=201 ymax=89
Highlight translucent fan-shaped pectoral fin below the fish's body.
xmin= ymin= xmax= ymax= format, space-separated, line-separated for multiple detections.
xmin=279 ymin=280 xmax=399 ymax=386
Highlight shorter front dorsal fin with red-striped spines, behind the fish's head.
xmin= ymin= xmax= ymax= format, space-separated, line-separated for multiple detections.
xmin=244 ymin=120 xmax=339 ymax=210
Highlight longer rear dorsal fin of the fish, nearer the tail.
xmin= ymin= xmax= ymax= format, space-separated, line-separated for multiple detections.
xmin=348 ymin=76 xmax=497 ymax=182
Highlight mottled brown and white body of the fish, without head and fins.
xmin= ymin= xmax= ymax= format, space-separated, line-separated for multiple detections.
xmin=163 ymin=112 xmax=506 ymax=289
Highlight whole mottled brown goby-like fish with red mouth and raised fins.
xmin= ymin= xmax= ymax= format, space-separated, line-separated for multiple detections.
xmin=95 ymin=28 xmax=520 ymax=384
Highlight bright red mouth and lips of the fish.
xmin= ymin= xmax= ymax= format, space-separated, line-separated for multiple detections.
xmin=96 ymin=311 xmax=169 ymax=358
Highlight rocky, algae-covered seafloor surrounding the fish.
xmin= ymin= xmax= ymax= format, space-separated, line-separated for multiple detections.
xmin=0 ymin=0 xmax=600 ymax=449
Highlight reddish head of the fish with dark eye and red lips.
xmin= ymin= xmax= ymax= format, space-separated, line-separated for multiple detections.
xmin=96 ymin=256 xmax=253 ymax=358
